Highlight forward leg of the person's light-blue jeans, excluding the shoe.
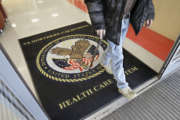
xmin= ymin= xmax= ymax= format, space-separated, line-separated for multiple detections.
xmin=111 ymin=19 xmax=129 ymax=89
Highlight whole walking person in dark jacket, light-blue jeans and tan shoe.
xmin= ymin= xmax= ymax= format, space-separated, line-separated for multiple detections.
xmin=85 ymin=0 xmax=155 ymax=99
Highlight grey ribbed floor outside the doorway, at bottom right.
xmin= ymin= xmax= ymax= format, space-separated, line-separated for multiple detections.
xmin=103 ymin=69 xmax=180 ymax=120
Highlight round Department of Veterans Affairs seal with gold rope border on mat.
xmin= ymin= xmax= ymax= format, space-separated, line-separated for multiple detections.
xmin=36 ymin=34 xmax=107 ymax=82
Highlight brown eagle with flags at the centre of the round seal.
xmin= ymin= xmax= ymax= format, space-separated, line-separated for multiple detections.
xmin=51 ymin=40 xmax=99 ymax=72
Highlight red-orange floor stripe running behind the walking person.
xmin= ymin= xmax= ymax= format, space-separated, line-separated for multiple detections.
xmin=68 ymin=0 xmax=174 ymax=61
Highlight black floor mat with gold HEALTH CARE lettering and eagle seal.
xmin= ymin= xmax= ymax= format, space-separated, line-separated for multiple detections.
xmin=20 ymin=22 xmax=157 ymax=120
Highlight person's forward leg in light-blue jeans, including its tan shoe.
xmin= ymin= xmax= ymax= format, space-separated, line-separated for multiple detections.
xmin=112 ymin=19 xmax=136 ymax=99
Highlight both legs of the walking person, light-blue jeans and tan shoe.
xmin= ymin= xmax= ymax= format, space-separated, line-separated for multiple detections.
xmin=101 ymin=16 xmax=136 ymax=99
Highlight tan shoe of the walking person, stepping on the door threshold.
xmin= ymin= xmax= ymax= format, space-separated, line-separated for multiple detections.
xmin=118 ymin=87 xmax=137 ymax=100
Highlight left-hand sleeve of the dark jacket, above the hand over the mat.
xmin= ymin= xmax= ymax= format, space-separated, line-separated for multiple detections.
xmin=85 ymin=0 xmax=105 ymax=29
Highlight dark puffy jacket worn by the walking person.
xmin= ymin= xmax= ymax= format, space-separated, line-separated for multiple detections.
xmin=85 ymin=0 xmax=154 ymax=44
